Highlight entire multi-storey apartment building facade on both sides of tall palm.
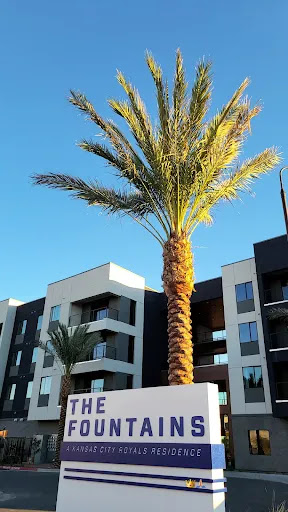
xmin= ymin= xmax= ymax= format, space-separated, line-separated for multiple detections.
xmin=0 ymin=236 xmax=288 ymax=472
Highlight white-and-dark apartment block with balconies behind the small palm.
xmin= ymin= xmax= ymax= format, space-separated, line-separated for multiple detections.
xmin=0 ymin=263 xmax=145 ymax=437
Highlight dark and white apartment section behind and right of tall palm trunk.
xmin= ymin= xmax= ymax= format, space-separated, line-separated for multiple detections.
xmin=143 ymin=236 xmax=288 ymax=472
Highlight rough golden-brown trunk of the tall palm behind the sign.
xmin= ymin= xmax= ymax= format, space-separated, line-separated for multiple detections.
xmin=162 ymin=235 xmax=194 ymax=385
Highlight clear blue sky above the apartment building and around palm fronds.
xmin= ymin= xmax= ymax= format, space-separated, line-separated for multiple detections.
xmin=0 ymin=0 xmax=288 ymax=301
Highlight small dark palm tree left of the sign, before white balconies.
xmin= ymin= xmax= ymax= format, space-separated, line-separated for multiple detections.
xmin=39 ymin=323 xmax=101 ymax=466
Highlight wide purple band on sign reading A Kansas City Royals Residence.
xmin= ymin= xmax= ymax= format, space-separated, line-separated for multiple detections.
xmin=61 ymin=441 xmax=225 ymax=469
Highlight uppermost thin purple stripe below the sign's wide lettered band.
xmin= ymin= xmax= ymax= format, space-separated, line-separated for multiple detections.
xmin=64 ymin=468 xmax=227 ymax=484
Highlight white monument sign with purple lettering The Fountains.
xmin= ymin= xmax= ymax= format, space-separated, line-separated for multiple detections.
xmin=57 ymin=383 xmax=225 ymax=512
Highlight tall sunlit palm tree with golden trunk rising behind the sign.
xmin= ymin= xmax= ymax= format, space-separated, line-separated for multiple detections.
xmin=32 ymin=50 xmax=279 ymax=384
